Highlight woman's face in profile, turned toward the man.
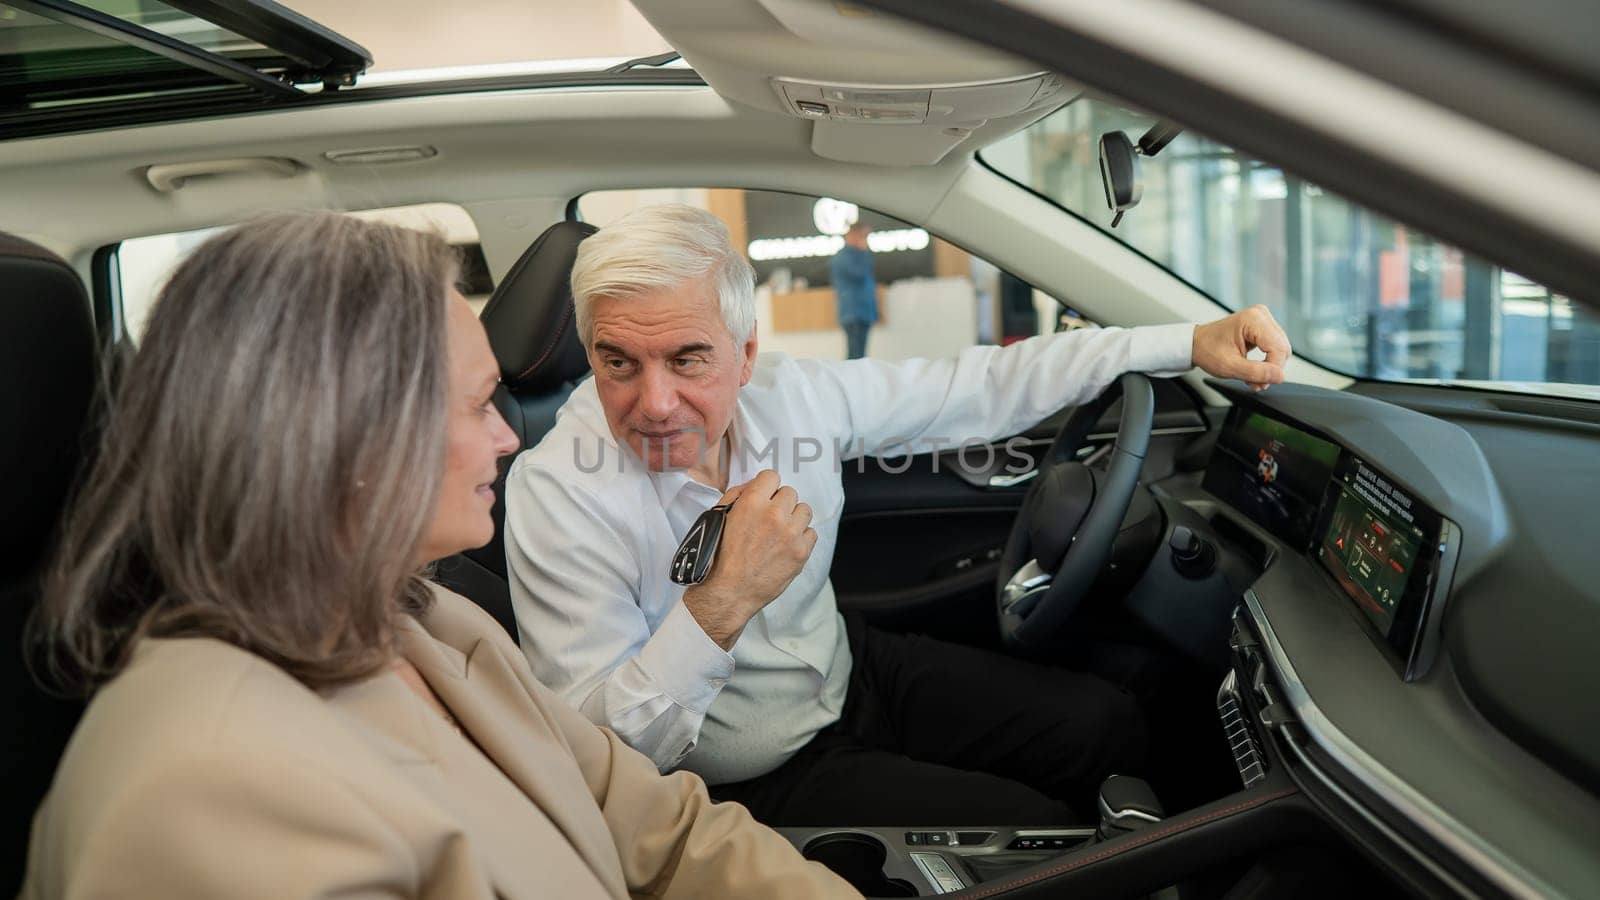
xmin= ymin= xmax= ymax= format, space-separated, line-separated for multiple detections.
xmin=421 ymin=291 xmax=518 ymax=562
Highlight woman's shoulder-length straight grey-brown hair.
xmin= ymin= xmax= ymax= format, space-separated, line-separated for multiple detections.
xmin=34 ymin=213 xmax=458 ymax=690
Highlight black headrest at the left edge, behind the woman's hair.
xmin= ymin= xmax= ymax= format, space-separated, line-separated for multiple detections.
xmin=0 ymin=234 xmax=96 ymax=566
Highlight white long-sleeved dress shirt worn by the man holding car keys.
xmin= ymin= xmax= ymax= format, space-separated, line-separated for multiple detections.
xmin=506 ymin=325 xmax=1194 ymax=785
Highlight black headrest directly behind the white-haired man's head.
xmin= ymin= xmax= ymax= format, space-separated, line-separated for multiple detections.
xmin=480 ymin=223 xmax=597 ymax=394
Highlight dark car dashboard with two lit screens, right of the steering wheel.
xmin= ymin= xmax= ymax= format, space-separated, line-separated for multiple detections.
xmin=1152 ymin=381 xmax=1600 ymax=897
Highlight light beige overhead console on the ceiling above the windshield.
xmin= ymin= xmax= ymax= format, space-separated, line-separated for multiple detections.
xmin=634 ymin=0 xmax=1083 ymax=167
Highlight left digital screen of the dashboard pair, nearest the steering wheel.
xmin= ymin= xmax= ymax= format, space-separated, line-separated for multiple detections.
xmin=1202 ymin=405 xmax=1339 ymax=549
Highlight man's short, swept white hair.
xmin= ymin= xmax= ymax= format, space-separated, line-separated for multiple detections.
xmin=573 ymin=203 xmax=755 ymax=348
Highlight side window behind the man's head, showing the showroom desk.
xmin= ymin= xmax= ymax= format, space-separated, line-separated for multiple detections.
xmin=578 ymin=189 xmax=1091 ymax=360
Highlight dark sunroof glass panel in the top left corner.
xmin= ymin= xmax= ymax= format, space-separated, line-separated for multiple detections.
xmin=0 ymin=0 xmax=282 ymax=107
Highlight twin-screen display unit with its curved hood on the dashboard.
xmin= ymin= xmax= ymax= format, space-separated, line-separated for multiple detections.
xmin=1202 ymin=384 xmax=1506 ymax=681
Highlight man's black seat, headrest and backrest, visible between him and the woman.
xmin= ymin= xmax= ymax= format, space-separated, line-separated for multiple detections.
xmin=435 ymin=223 xmax=595 ymax=637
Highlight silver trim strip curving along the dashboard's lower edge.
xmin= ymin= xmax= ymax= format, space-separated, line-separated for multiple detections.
xmin=1245 ymin=591 xmax=1557 ymax=900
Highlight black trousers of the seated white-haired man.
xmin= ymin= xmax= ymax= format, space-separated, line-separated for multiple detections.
xmin=710 ymin=615 xmax=1146 ymax=826
